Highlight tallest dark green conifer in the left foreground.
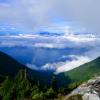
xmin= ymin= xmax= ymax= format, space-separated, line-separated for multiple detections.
xmin=14 ymin=70 xmax=31 ymax=100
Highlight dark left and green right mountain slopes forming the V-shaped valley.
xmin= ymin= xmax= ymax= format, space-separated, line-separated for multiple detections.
xmin=0 ymin=49 xmax=100 ymax=86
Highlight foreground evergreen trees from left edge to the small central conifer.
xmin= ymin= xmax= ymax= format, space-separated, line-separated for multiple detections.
xmin=0 ymin=69 xmax=58 ymax=100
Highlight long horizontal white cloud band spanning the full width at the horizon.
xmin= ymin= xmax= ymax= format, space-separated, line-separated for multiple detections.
xmin=0 ymin=33 xmax=100 ymax=49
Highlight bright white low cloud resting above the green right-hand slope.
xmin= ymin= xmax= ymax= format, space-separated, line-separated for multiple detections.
xmin=41 ymin=55 xmax=91 ymax=74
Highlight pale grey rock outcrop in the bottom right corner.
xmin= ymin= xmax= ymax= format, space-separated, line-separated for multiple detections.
xmin=65 ymin=77 xmax=100 ymax=100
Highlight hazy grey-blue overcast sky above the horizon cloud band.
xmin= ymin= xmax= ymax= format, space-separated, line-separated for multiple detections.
xmin=0 ymin=0 xmax=100 ymax=34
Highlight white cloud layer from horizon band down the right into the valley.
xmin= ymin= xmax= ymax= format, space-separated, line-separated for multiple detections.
xmin=0 ymin=34 xmax=100 ymax=73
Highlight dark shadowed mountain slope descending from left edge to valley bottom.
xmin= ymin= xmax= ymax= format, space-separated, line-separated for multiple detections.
xmin=0 ymin=51 xmax=53 ymax=84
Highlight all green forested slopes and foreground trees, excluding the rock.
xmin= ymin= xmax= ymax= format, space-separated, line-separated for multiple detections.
xmin=0 ymin=52 xmax=95 ymax=100
